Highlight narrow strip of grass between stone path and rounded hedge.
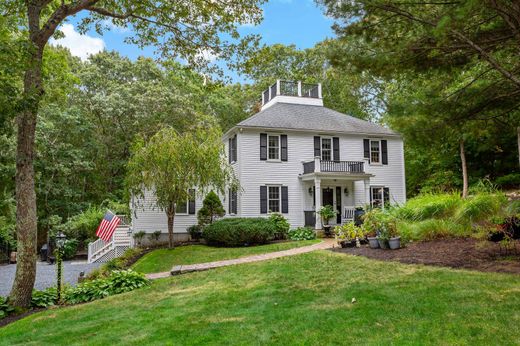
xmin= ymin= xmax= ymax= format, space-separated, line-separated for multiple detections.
xmin=132 ymin=239 xmax=320 ymax=273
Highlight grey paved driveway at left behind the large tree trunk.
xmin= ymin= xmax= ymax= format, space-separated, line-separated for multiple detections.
xmin=0 ymin=261 xmax=101 ymax=296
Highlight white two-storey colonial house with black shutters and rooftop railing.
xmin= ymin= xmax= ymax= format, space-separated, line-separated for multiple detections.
xmin=89 ymin=80 xmax=406 ymax=262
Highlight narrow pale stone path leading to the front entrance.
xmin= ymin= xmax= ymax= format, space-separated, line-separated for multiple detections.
xmin=146 ymin=239 xmax=335 ymax=280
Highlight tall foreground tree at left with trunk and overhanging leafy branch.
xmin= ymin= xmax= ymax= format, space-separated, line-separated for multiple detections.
xmin=0 ymin=0 xmax=261 ymax=307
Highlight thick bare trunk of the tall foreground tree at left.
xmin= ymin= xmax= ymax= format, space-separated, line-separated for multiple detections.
xmin=9 ymin=37 xmax=43 ymax=307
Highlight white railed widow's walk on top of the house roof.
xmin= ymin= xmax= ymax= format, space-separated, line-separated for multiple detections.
xmin=262 ymin=79 xmax=323 ymax=110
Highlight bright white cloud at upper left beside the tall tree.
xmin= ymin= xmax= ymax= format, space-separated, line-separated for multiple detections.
xmin=50 ymin=23 xmax=105 ymax=60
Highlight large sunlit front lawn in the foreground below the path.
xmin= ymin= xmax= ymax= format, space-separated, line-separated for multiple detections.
xmin=0 ymin=251 xmax=520 ymax=345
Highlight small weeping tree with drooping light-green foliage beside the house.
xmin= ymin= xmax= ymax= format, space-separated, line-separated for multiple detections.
xmin=128 ymin=118 xmax=237 ymax=248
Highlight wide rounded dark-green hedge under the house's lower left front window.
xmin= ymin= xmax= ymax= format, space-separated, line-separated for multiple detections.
xmin=203 ymin=217 xmax=277 ymax=246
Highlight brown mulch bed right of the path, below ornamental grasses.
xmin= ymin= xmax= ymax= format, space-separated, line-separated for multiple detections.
xmin=331 ymin=239 xmax=520 ymax=274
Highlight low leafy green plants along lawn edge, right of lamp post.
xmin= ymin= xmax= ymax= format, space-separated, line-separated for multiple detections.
xmin=64 ymin=270 xmax=149 ymax=304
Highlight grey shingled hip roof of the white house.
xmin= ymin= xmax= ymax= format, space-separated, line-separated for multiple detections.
xmin=237 ymin=102 xmax=399 ymax=136
